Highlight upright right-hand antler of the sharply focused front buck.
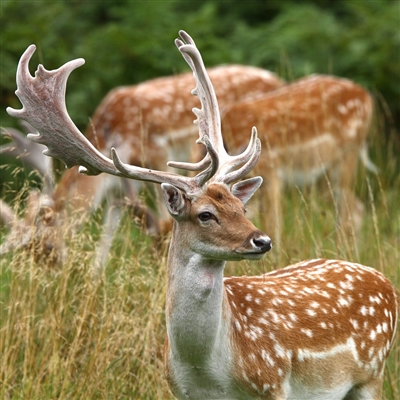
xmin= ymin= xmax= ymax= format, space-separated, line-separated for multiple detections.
xmin=174 ymin=31 xmax=261 ymax=184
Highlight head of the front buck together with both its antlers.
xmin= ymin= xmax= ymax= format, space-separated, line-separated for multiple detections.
xmin=7 ymin=31 xmax=271 ymax=266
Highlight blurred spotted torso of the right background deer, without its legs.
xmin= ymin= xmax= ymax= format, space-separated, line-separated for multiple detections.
xmin=222 ymin=75 xmax=373 ymax=175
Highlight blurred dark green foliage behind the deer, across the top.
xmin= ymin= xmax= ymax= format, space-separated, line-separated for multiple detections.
xmin=0 ymin=0 xmax=400 ymax=129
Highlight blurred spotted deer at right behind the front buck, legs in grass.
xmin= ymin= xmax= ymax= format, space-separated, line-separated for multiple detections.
xmin=222 ymin=75 xmax=377 ymax=245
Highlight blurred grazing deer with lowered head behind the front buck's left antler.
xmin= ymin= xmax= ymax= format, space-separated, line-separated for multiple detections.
xmin=0 ymin=65 xmax=284 ymax=268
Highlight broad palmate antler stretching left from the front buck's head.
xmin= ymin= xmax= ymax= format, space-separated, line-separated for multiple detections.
xmin=7 ymin=45 xmax=218 ymax=192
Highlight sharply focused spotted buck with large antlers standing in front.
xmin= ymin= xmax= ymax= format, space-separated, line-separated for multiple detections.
xmin=7 ymin=31 xmax=398 ymax=400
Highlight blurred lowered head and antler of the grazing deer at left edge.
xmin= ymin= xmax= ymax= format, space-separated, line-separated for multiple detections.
xmin=0 ymin=125 xmax=65 ymax=265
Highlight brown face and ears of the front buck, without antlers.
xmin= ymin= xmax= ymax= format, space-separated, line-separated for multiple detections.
xmin=162 ymin=179 xmax=272 ymax=261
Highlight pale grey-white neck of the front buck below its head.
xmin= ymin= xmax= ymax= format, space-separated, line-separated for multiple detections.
xmin=166 ymin=223 xmax=229 ymax=368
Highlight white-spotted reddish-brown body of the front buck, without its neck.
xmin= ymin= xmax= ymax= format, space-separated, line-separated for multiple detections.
xmin=224 ymin=260 xmax=398 ymax=399
